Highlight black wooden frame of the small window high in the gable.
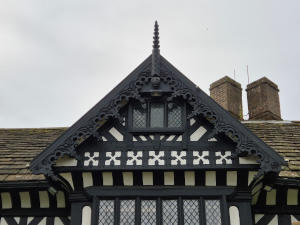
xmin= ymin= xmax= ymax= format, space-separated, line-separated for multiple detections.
xmin=128 ymin=99 xmax=186 ymax=133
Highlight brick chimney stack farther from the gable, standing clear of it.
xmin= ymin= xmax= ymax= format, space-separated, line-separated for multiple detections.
xmin=246 ymin=77 xmax=282 ymax=120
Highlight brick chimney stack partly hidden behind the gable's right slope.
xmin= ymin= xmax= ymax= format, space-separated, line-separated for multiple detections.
xmin=209 ymin=76 xmax=243 ymax=120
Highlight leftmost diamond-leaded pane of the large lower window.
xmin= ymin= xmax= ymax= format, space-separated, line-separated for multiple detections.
xmin=98 ymin=200 xmax=114 ymax=225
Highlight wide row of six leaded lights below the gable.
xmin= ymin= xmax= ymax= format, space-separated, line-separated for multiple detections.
xmin=97 ymin=197 xmax=224 ymax=225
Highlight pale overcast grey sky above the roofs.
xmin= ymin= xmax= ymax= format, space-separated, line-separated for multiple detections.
xmin=0 ymin=0 xmax=300 ymax=128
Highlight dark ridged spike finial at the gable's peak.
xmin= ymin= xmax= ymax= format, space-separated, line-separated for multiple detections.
xmin=151 ymin=21 xmax=160 ymax=76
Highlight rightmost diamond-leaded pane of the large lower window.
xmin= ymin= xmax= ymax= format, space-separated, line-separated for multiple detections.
xmin=205 ymin=200 xmax=222 ymax=225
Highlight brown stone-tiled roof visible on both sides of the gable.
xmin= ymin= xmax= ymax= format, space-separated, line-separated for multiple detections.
xmin=0 ymin=121 xmax=300 ymax=181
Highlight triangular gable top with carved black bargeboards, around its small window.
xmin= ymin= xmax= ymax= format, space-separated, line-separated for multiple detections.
xmin=30 ymin=25 xmax=285 ymax=179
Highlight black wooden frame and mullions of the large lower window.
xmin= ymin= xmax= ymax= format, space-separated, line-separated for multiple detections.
xmin=86 ymin=187 xmax=234 ymax=225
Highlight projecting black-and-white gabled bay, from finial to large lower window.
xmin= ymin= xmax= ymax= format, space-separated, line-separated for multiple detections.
xmin=31 ymin=21 xmax=284 ymax=224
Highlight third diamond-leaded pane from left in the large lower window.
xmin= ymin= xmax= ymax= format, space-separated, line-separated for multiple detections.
xmin=141 ymin=200 xmax=156 ymax=225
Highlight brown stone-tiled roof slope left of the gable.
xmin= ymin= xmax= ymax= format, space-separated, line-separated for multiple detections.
xmin=0 ymin=128 xmax=66 ymax=181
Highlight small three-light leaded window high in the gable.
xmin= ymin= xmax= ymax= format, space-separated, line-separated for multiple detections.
xmin=132 ymin=101 xmax=184 ymax=130
